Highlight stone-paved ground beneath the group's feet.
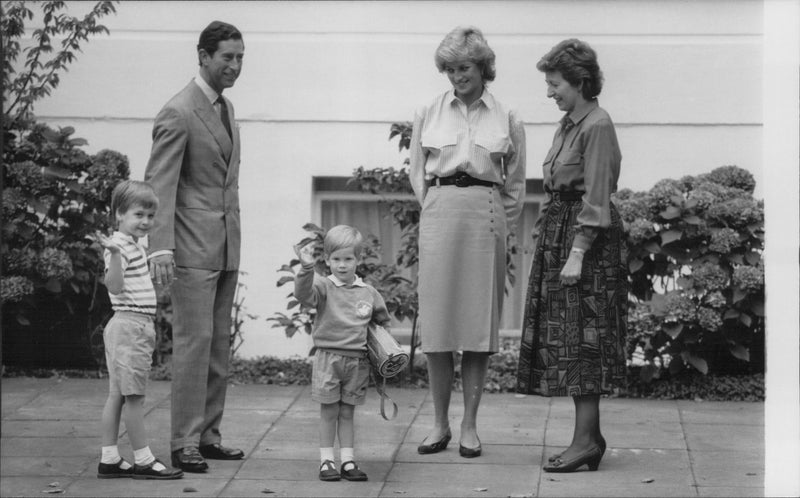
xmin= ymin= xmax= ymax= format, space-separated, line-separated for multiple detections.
xmin=0 ymin=378 xmax=764 ymax=497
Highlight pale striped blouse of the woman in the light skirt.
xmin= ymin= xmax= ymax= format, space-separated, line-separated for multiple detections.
xmin=409 ymin=89 xmax=525 ymax=231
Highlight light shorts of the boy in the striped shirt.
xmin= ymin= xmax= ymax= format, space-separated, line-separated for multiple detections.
xmin=103 ymin=311 xmax=156 ymax=396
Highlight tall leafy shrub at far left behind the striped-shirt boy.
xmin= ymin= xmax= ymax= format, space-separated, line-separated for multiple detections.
xmin=0 ymin=2 xmax=120 ymax=370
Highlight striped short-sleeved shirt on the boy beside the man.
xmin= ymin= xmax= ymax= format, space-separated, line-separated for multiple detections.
xmin=103 ymin=231 xmax=156 ymax=315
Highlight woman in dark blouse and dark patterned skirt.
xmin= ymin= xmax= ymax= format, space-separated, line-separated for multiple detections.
xmin=517 ymin=39 xmax=628 ymax=472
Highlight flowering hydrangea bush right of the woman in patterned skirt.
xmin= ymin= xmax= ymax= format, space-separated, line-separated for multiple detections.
xmin=614 ymin=166 xmax=764 ymax=380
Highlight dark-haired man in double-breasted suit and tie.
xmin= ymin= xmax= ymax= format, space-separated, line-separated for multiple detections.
xmin=145 ymin=21 xmax=244 ymax=472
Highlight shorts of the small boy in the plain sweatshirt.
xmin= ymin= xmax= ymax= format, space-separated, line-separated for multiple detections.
xmin=311 ymin=349 xmax=369 ymax=405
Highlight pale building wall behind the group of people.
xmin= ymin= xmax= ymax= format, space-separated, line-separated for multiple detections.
xmin=25 ymin=0 xmax=764 ymax=356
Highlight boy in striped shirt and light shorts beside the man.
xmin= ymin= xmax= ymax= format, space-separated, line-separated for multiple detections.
xmin=96 ymin=180 xmax=183 ymax=479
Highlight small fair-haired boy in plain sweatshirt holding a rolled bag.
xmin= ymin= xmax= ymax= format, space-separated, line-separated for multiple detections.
xmin=294 ymin=225 xmax=389 ymax=481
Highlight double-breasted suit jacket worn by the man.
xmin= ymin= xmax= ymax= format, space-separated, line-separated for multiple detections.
xmin=145 ymin=81 xmax=241 ymax=270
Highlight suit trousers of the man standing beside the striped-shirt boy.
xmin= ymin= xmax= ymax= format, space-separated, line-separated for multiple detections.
xmin=170 ymin=266 xmax=239 ymax=451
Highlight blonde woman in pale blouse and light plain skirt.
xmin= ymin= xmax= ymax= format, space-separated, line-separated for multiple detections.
xmin=409 ymin=27 xmax=525 ymax=458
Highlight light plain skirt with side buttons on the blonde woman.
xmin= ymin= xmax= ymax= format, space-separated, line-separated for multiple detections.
xmin=417 ymin=186 xmax=506 ymax=353
